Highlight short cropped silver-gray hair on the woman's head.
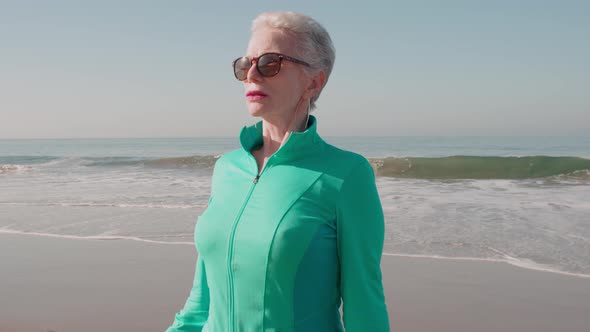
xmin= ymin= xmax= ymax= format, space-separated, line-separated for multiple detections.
xmin=252 ymin=11 xmax=336 ymax=110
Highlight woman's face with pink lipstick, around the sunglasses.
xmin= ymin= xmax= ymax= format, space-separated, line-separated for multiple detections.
xmin=244 ymin=27 xmax=311 ymax=120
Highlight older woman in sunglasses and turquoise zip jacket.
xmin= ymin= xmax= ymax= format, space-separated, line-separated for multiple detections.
xmin=168 ymin=12 xmax=389 ymax=332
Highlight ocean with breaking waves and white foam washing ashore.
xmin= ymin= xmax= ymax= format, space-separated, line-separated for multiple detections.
xmin=0 ymin=136 xmax=590 ymax=277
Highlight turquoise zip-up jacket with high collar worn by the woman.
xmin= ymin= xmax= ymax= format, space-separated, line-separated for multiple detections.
xmin=167 ymin=116 xmax=389 ymax=332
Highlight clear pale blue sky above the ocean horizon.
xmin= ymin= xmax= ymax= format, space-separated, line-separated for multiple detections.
xmin=0 ymin=0 xmax=590 ymax=138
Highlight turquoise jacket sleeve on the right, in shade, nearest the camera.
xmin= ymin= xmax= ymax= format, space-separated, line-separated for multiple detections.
xmin=337 ymin=158 xmax=389 ymax=332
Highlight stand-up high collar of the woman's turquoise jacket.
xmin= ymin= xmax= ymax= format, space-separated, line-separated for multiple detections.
xmin=240 ymin=115 xmax=322 ymax=159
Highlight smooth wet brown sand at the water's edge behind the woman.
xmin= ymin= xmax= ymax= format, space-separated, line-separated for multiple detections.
xmin=0 ymin=234 xmax=590 ymax=332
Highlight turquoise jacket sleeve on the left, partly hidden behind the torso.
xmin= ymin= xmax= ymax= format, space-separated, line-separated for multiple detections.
xmin=166 ymin=255 xmax=209 ymax=332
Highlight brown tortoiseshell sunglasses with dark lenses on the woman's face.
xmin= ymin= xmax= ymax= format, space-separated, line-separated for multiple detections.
xmin=232 ymin=53 xmax=311 ymax=81
